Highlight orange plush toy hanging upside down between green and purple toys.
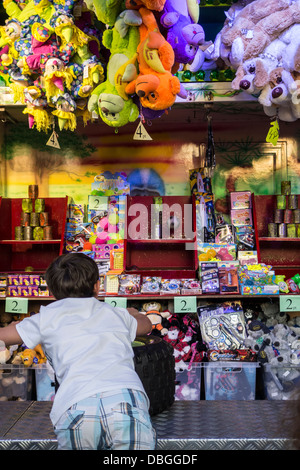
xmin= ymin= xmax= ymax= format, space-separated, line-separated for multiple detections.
xmin=125 ymin=7 xmax=180 ymax=110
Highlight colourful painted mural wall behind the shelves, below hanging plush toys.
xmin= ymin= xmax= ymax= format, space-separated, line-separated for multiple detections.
xmin=0 ymin=103 xmax=300 ymax=220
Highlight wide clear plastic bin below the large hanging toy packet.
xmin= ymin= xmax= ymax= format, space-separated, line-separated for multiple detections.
xmin=203 ymin=361 xmax=259 ymax=400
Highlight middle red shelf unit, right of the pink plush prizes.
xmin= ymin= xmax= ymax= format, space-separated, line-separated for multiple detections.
xmin=124 ymin=196 xmax=197 ymax=279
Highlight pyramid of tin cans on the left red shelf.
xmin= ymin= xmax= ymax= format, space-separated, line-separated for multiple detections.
xmin=15 ymin=185 xmax=52 ymax=240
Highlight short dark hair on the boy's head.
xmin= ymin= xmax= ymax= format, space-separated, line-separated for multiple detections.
xmin=45 ymin=253 xmax=99 ymax=300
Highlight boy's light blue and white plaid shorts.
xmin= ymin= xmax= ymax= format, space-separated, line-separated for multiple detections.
xmin=54 ymin=389 xmax=156 ymax=450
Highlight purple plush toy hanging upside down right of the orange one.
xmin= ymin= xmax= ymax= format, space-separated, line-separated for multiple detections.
xmin=160 ymin=0 xmax=205 ymax=64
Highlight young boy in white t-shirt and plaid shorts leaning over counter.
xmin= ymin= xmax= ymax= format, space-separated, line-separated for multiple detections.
xmin=0 ymin=253 xmax=155 ymax=450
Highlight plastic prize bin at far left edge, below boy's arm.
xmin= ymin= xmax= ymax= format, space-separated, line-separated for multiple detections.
xmin=0 ymin=364 xmax=32 ymax=401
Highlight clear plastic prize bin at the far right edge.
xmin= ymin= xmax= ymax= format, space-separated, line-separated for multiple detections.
xmin=263 ymin=363 xmax=300 ymax=400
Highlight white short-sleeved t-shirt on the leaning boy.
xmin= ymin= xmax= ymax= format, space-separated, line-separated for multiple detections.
xmin=16 ymin=297 xmax=144 ymax=425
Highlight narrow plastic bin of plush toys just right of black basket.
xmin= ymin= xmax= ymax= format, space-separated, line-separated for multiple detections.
xmin=175 ymin=362 xmax=202 ymax=401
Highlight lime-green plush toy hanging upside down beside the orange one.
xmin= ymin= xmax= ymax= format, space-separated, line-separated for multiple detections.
xmin=88 ymin=10 xmax=142 ymax=128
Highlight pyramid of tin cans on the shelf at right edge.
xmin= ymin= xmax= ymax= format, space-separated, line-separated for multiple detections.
xmin=268 ymin=181 xmax=300 ymax=238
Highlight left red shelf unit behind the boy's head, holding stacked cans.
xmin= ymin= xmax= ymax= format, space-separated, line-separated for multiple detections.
xmin=0 ymin=196 xmax=68 ymax=273
